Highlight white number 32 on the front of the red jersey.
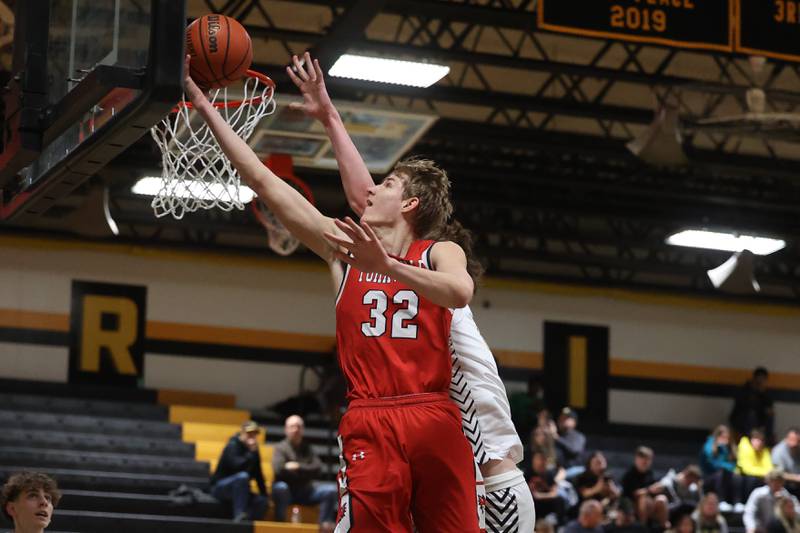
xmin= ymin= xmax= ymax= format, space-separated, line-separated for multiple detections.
xmin=361 ymin=289 xmax=419 ymax=339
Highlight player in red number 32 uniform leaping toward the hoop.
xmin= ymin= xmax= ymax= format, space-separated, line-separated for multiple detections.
xmin=184 ymin=57 xmax=478 ymax=533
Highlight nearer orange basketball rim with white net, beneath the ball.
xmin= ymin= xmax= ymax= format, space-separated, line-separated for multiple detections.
xmin=150 ymin=70 xmax=275 ymax=219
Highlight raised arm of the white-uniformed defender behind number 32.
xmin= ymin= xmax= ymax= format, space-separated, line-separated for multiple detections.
xmin=286 ymin=52 xmax=375 ymax=217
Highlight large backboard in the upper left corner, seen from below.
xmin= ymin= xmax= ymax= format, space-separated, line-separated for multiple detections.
xmin=0 ymin=0 xmax=186 ymax=220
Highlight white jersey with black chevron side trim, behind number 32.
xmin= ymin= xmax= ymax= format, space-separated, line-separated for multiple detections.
xmin=450 ymin=307 xmax=522 ymax=465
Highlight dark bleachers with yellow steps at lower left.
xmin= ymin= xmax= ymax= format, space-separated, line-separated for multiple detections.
xmin=0 ymin=380 xmax=335 ymax=533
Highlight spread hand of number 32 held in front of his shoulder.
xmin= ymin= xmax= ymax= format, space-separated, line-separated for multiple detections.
xmin=325 ymin=217 xmax=393 ymax=275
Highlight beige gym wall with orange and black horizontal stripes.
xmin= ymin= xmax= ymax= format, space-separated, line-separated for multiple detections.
xmin=0 ymin=237 xmax=800 ymax=434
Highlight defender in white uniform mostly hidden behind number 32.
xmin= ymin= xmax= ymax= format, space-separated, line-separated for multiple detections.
xmin=287 ymin=52 xmax=535 ymax=533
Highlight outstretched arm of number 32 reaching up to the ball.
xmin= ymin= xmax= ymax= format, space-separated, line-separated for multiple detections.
xmin=184 ymin=56 xmax=338 ymax=262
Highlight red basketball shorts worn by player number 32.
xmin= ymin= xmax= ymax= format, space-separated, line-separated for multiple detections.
xmin=336 ymin=393 xmax=478 ymax=533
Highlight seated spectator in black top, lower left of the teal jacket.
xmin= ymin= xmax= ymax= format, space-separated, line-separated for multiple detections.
xmin=622 ymin=446 xmax=669 ymax=529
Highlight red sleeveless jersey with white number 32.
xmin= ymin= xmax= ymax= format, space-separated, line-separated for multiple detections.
xmin=336 ymin=241 xmax=452 ymax=400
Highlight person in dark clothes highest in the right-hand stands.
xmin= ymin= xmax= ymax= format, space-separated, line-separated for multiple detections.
xmin=730 ymin=366 xmax=775 ymax=444
